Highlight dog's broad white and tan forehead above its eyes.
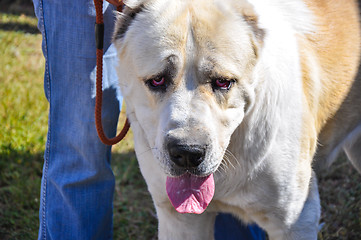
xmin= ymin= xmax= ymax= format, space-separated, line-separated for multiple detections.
xmin=116 ymin=0 xmax=253 ymax=79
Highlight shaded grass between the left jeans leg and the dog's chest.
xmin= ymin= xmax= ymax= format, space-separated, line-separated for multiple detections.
xmin=112 ymin=152 xmax=158 ymax=239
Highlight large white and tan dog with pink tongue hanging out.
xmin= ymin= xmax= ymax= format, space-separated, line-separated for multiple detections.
xmin=114 ymin=0 xmax=361 ymax=240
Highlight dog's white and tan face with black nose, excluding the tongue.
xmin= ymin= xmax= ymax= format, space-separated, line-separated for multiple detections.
xmin=114 ymin=0 xmax=262 ymax=176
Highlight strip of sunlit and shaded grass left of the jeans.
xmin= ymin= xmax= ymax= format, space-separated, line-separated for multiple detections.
xmin=0 ymin=14 xmax=47 ymax=239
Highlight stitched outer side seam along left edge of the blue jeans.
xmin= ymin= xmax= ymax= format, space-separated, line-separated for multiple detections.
xmin=39 ymin=0 xmax=51 ymax=240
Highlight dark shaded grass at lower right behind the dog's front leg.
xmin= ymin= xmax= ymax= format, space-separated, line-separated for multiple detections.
xmin=318 ymin=155 xmax=361 ymax=240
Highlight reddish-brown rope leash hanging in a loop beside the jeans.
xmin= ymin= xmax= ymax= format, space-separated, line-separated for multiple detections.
xmin=94 ymin=0 xmax=130 ymax=145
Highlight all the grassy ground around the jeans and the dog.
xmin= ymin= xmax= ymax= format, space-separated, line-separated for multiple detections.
xmin=0 ymin=8 xmax=361 ymax=240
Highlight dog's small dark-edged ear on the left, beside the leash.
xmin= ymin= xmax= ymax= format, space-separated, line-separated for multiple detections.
xmin=113 ymin=0 xmax=144 ymax=42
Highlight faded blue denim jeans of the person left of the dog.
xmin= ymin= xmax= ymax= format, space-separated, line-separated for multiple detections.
xmin=34 ymin=0 xmax=261 ymax=240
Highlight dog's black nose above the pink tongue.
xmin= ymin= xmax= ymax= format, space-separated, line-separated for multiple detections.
xmin=167 ymin=141 xmax=206 ymax=168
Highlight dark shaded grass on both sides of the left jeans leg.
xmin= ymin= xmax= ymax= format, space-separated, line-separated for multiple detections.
xmin=0 ymin=144 xmax=157 ymax=240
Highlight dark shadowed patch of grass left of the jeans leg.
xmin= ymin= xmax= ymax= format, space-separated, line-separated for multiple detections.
xmin=0 ymin=144 xmax=43 ymax=240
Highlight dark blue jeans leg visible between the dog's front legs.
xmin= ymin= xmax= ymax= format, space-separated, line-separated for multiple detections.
xmin=214 ymin=213 xmax=266 ymax=240
